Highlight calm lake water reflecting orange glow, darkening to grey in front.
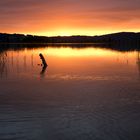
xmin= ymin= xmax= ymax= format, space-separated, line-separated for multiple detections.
xmin=0 ymin=46 xmax=140 ymax=140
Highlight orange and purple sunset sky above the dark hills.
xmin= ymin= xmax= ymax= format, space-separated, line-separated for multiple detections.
xmin=0 ymin=0 xmax=140 ymax=36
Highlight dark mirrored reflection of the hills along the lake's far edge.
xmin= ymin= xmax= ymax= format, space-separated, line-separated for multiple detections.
xmin=0 ymin=42 xmax=140 ymax=52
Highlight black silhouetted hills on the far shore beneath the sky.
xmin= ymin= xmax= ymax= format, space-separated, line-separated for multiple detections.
xmin=0 ymin=32 xmax=140 ymax=44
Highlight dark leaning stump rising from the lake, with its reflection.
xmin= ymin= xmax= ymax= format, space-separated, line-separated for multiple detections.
xmin=39 ymin=53 xmax=48 ymax=77
